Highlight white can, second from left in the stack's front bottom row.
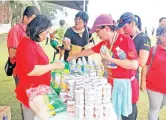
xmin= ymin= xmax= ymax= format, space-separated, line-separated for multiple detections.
xmin=75 ymin=104 xmax=84 ymax=119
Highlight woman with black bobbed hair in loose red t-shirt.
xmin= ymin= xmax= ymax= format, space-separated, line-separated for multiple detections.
xmin=15 ymin=15 xmax=64 ymax=120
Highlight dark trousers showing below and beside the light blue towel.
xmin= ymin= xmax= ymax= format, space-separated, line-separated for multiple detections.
xmin=122 ymin=103 xmax=138 ymax=120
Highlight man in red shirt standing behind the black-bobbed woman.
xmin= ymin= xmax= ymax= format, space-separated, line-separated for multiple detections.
xmin=7 ymin=6 xmax=40 ymax=85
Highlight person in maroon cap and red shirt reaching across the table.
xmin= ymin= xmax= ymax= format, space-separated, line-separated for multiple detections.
xmin=68 ymin=14 xmax=139 ymax=120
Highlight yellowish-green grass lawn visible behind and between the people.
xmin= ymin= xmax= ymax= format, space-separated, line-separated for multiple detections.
xmin=0 ymin=34 xmax=166 ymax=120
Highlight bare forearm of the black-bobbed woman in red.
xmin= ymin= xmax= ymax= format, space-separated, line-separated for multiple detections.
xmin=28 ymin=61 xmax=64 ymax=76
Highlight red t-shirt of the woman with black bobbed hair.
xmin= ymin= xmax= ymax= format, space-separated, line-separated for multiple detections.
xmin=15 ymin=37 xmax=51 ymax=107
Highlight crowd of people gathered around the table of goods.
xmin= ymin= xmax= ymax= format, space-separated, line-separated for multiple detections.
xmin=7 ymin=6 xmax=166 ymax=120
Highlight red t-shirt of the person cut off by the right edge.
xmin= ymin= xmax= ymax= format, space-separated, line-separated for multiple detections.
xmin=146 ymin=45 xmax=166 ymax=94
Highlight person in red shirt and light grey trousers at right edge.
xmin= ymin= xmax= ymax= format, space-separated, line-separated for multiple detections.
xmin=141 ymin=27 xmax=166 ymax=120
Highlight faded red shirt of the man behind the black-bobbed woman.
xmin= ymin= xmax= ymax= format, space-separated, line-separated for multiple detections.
xmin=7 ymin=23 xmax=26 ymax=75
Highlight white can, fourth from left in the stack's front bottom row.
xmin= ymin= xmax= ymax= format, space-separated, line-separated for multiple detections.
xmin=95 ymin=104 xmax=103 ymax=120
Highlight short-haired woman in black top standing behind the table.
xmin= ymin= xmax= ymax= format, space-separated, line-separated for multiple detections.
xmin=63 ymin=11 xmax=89 ymax=61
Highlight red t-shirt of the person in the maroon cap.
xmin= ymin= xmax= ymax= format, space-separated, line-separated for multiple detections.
xmin=92 ymin=34 xmax=139 ymax=103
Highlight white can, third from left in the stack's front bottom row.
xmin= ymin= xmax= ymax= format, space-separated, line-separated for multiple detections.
xmin=85 ymin=105 xmax=94 ymax=120
